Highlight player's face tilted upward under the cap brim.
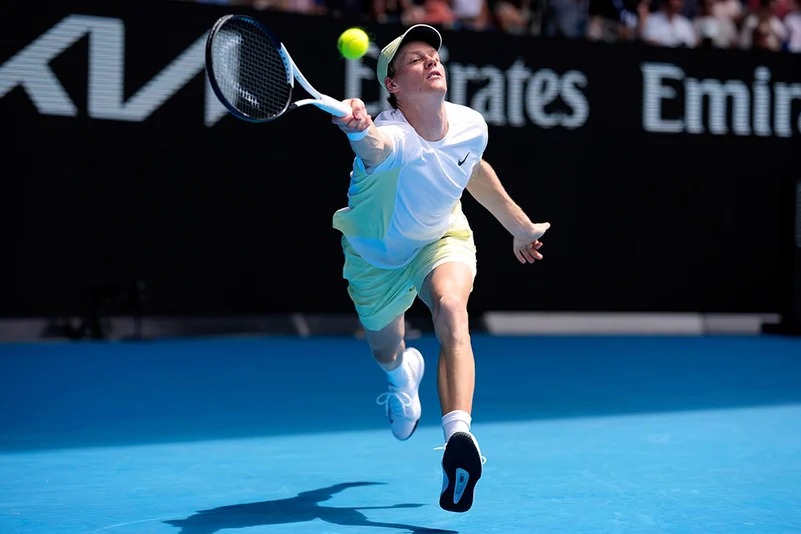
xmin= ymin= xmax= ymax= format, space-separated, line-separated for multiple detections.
xmin=392 ymin=41 xmax=448 ymax=95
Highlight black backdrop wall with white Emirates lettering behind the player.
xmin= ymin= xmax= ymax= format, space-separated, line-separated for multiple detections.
xmin=0 ymin=0 xmax=801 ymax=316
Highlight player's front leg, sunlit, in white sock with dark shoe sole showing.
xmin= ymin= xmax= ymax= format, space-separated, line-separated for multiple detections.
xmin=420 ymin=261 xmax=482 ymax=512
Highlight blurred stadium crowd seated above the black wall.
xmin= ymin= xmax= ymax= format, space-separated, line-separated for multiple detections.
xmin=187 ymin=0 xmax=801 ymax=53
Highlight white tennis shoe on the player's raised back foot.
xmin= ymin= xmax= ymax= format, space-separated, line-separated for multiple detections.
xmin=376 ymin=347 xmax=425 ymax=441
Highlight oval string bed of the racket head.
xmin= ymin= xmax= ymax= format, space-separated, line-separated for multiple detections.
xmin=212 ymin=20 xmax=291 ymax=120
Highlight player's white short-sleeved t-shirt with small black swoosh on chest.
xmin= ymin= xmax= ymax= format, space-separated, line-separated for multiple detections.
xmin=333 ymin=102 xmax=488 ymax=269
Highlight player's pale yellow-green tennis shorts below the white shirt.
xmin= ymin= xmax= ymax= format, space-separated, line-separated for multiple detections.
xmin=342 ymin=210 xmax=476 ymax=330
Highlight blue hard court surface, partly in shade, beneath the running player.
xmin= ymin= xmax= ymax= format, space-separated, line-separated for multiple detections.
xmin=0 ymin=335 xmax=801 ymax=534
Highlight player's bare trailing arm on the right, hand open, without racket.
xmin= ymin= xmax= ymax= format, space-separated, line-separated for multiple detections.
xmin=467 ymin=159 xmax=551 ymax=263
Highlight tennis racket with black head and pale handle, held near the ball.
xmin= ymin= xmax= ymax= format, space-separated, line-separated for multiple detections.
xmin=206 ymin=15 xmax=351 ymax=122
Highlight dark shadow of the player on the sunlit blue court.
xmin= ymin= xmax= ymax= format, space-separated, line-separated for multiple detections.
xmin=165 ymin=482 xmax=458 ymax=534
